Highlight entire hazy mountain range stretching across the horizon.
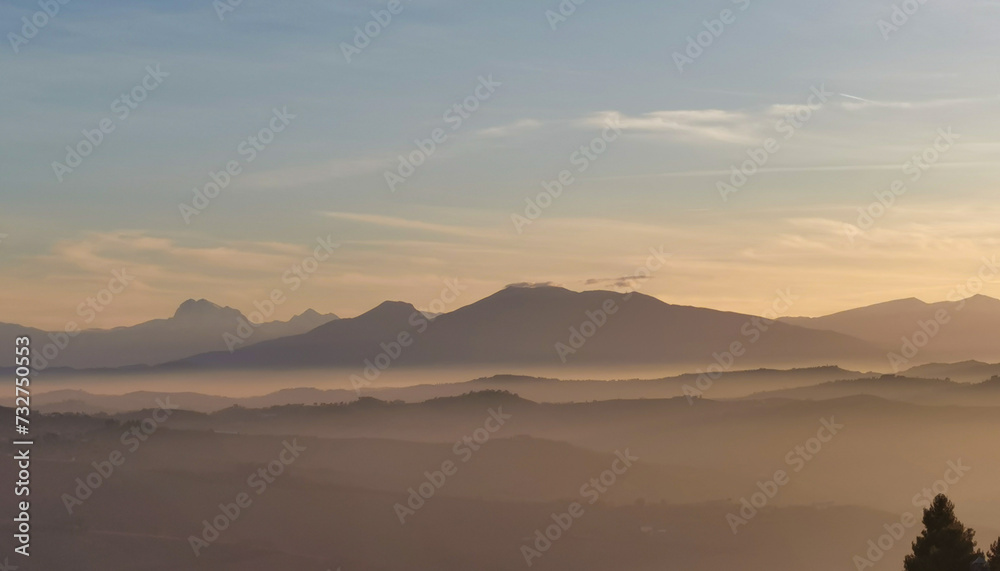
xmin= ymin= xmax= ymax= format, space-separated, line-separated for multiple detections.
xmin=7 ymin=286 xmax=1000 ymax=374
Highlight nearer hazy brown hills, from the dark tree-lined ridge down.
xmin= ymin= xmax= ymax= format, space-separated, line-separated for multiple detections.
xmin=9 ymin=386 xmax=1000 ymax=571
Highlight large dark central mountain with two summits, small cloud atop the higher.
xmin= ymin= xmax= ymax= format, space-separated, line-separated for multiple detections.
xmin=172 ymin=287 xmax=884 ymax=371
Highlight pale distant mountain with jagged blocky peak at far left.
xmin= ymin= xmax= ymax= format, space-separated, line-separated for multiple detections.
xmin=0 ymin=299 xmax=337 ymax=368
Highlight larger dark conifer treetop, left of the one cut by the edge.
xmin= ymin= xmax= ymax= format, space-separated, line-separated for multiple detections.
xmin=903 ymin=494 xmax=981 ymax=571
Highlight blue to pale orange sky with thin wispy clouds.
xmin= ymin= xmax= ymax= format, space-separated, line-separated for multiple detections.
xmin=0 ymin=0 xmax=1000 ymax=328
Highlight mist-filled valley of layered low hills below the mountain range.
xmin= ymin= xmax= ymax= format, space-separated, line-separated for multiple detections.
xmin=3 ymin=367 xmax=1000 ymax=570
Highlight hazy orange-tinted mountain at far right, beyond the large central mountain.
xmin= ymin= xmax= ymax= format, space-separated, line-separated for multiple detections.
xmin=781 ymin=295 xmax=1000 ymax=364
